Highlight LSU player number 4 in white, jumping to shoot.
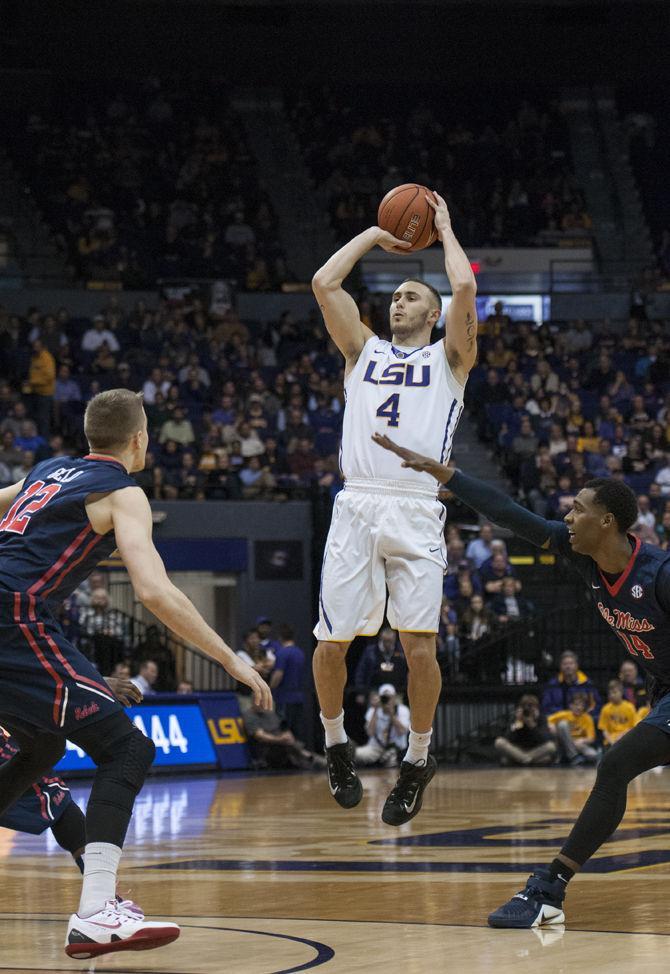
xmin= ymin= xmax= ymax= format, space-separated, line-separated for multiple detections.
xmin=312 ymin=194 xmax=477 ymax=825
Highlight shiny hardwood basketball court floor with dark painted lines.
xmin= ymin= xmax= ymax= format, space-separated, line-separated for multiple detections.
xmin=0 ymin=769 xmax=670 ymax=974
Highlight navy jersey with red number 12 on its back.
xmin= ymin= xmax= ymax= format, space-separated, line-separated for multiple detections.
xmin=0 ymin=454 xmax=137 ymax=602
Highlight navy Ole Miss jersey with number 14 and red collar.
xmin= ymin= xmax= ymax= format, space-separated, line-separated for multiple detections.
xmin=551 ymin=525 xmax=670 ymax=684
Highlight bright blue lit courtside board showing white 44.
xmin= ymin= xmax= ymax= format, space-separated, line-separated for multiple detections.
xmin=56 ymin=699 xmax=218 ymax=771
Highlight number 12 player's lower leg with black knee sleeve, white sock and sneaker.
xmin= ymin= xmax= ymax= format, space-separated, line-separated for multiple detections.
xmin=65 ymin=710 xmax=179 ymax=959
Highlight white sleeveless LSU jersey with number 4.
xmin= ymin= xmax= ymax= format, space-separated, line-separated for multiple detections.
xmin=340 ymin=338 xmax=463 ymax=489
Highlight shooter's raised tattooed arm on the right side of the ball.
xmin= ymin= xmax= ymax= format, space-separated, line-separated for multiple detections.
xmin=426 ymin=190 xmax=477 ymax=382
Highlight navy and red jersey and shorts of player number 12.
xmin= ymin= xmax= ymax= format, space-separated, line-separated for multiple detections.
xmin=0 ymin=455 xmax=136 ymax=736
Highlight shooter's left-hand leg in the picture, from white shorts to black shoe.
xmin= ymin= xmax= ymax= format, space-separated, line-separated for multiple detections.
xmin=312 ymin=491 xmax=386 ymax=808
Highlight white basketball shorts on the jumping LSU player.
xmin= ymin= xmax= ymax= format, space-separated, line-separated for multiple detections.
xmin=314 ymin=480 xmax=447 ymax=642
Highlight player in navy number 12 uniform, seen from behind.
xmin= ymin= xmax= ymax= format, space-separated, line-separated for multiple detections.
xmin=0 ymin=389 xmax=272 ymax=959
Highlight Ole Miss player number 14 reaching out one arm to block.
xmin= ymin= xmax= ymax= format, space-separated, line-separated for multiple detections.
xmin=375 ymin=436 xmax=670 ymax=927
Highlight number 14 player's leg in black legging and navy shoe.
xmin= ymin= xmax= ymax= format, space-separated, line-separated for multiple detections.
xmin=489 ymin=724 xmax=670 ymax=927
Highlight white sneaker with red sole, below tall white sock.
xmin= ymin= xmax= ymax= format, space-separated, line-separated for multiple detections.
xmin=65 ymin=900 xmax=181 ymax=960
